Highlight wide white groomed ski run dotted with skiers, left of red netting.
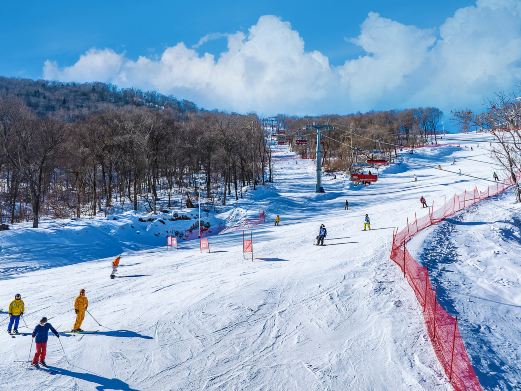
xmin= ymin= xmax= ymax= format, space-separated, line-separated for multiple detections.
xmin=0 ymin=136 xmax=491 ymax=390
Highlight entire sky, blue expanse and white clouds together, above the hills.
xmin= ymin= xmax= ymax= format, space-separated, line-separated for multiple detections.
xmin=0 ymin=0 xmax=521 ymax=114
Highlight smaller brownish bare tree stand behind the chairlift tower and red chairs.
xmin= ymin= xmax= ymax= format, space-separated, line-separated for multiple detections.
xmin=284 ymin=107 xmax=443 ymax=171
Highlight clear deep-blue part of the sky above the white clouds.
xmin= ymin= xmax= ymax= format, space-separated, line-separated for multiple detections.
xmin=0 ymin=0 xmax=473 ymax=78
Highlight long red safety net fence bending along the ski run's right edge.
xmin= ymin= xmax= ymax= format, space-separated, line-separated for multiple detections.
xmin=391 ymin=181 xmax=512 ymax=391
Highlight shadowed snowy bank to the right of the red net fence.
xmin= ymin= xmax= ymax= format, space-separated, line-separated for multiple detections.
xmin=411 ymin=192 xmax=521 ymax=390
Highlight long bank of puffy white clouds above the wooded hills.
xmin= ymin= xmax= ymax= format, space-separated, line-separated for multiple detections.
xmin=44 ymin=0 xmax=521 ymax=114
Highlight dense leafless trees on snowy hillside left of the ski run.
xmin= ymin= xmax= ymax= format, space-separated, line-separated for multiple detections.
xmin=0 ymin=77 xmax=268 ymax=227
